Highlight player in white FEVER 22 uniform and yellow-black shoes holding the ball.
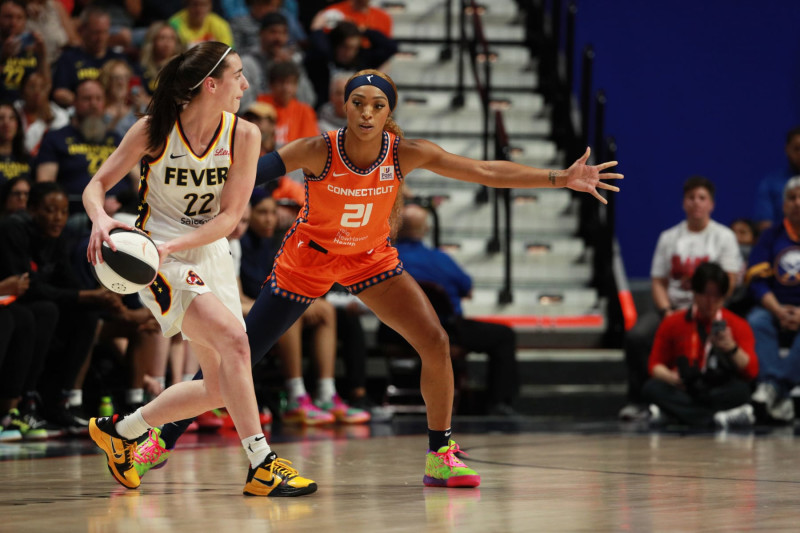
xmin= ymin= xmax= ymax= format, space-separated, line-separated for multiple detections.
xmin=83 ymin=42 xmax=317 ymax=496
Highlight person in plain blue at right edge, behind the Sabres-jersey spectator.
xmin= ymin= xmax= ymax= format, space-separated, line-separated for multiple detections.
xmin=753 ymin=126 xmax=800 ymax=230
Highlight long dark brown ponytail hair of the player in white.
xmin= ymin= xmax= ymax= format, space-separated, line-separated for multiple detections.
xmin=145 ymin=41 xmax=236 ymax=150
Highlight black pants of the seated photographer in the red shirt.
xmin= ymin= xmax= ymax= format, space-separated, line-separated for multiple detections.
xmin=642 ymin=378 xmax=750 ymax=427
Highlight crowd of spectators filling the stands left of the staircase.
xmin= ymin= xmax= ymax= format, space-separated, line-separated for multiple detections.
xmin=0 ymin=0 xmax=397 ymax=440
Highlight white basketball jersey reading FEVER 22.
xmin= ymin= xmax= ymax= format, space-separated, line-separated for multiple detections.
xmin=136 ymin=112 xmax=238 ymax=242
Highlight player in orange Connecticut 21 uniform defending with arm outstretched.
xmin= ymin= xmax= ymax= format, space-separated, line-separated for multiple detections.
xmin=136 ymin=70 xmax=622 ymax=487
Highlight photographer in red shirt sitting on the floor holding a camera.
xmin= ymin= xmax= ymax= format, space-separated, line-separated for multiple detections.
xmin=642 ymin=263 xmax=758 ymax=428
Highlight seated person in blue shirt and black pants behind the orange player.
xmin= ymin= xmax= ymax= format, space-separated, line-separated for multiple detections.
xmin=395 ymin=204 xmax=518 ymax=416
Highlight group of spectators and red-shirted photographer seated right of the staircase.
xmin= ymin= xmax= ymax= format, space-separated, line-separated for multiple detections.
xmin=620 ymin=128 xmax=800 ymax=427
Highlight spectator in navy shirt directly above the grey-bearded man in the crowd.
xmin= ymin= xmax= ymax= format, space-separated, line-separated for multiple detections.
xmin=52 ymin=5 xmax=126 ymax=108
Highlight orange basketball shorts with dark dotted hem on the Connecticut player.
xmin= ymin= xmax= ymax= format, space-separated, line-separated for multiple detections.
xmin=264 ymin=233 xmax=403 ymax=303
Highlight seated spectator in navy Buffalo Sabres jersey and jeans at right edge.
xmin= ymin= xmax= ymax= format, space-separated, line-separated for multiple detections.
xmin=747 ymin=175 xmax=800 ymax=422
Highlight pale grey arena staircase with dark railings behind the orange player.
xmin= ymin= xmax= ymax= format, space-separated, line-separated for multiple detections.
xmin=354 ymin=0 xmax=625 ymax=418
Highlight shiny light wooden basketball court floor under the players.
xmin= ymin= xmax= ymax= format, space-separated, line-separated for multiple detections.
xmin=0 ymin=422 xmax=800 ymax=533
